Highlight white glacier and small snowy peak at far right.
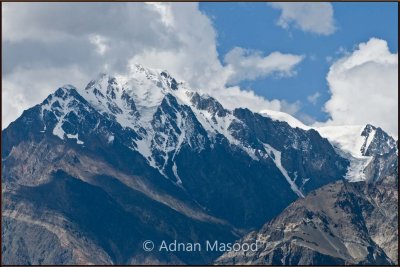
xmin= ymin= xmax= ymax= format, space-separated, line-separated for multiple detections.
xmin=260 ymin=110 xmax=398 ymax=182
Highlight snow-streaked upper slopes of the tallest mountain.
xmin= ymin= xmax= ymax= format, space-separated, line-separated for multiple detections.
xmin=27 ymin=65 xmax=350 ymax=200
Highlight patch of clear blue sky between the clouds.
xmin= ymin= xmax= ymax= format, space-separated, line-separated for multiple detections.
xmin=200 ymin=3 xmax=398 ymax=121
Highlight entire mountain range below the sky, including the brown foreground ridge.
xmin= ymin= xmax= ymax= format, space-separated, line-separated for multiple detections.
xmin=2 ymin=65 xmax=398 ymax=264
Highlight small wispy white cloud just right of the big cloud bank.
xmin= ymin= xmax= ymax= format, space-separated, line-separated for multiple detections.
xmin=224 ymin=47 xmax=304 ymax=84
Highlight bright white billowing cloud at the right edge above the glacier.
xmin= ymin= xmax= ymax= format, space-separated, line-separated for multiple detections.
xmin=318 ymin=38 xmax=399 ymax=137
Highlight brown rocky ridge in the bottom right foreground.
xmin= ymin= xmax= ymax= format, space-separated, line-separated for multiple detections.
xmin=216 ymin=176 xmax=398 ymax=265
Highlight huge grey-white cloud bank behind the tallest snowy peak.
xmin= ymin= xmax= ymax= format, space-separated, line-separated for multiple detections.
xmin=2 ymin=3 xmax=299 ymax=128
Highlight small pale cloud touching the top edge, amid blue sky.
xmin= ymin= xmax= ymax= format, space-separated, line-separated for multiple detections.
xmin=269 ymin=2 xmax=336 ymax=35
